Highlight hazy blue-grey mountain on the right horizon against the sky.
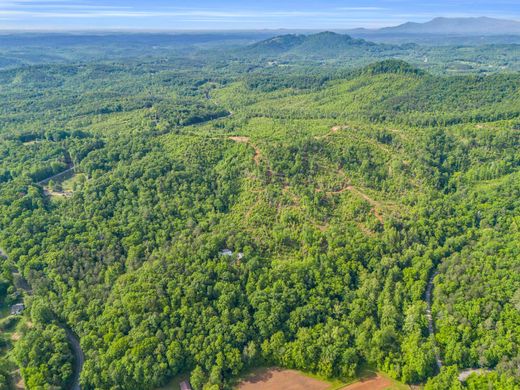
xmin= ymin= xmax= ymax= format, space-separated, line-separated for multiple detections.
xmin=348 ymin=17 xmax=520 ymax=36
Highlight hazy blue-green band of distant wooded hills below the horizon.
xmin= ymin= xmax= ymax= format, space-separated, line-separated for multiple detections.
xmin=0 ymin=30 xmax=520 ymax=75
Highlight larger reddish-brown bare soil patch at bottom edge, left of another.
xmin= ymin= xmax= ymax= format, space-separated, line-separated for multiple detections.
xmin=238 ymin=368 xmax=330 ymax=390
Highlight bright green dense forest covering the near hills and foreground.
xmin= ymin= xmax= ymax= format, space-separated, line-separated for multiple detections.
xmin=0 ymin=36 xmax=520 ymax=389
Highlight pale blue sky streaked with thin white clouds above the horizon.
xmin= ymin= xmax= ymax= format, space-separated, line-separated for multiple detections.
xmin=0 ymin=0 xmax=520 ymax=30
